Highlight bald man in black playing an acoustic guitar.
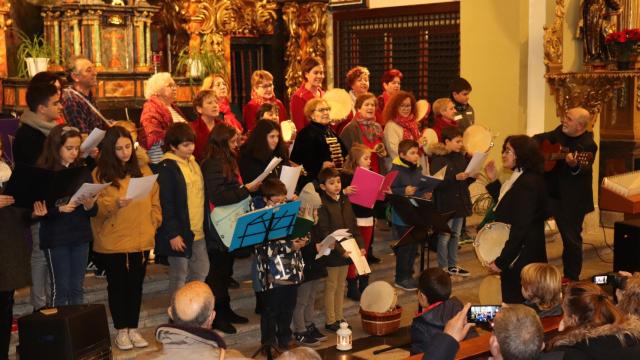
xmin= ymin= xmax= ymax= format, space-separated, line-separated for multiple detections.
xmin=534 ymin=107 xmax=598 ymax=281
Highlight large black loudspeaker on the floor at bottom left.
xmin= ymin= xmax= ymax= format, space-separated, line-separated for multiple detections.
xmin=17 ymin=304 xmax=111 ymax=360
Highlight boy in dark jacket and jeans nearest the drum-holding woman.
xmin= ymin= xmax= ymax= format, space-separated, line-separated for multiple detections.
xmin=429 ymin=126 xmax=476 ymax=276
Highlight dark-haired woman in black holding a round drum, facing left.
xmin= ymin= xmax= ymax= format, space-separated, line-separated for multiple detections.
xmin=485 ymin=135 xmax=547 ymax=303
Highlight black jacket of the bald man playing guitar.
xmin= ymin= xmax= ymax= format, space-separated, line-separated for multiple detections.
xmin=534 ymin=126 xmax=598 ymax=214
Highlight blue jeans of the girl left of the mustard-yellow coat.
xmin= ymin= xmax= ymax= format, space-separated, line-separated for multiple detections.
xmin=44 ymin=243 xmax=89 ymax=306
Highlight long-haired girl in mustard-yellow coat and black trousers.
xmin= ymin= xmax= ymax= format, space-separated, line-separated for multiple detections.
xmin=91 ymin=126 xmax=162 ymax=350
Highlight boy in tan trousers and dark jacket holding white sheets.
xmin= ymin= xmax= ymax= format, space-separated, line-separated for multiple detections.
xmin=313 ymin=168 xmax=366 ymax=331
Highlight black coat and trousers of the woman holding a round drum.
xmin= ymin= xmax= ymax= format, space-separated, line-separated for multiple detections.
xmin=487 ymin=171 xmax=547 ymax=303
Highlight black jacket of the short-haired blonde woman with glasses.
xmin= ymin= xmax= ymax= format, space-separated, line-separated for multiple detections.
xmin=291 ymin=121 xmax=347 ymax=186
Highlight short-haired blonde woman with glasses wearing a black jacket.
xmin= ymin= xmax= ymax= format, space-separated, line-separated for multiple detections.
xmin=291 ymin=99 xmax=347 ymax=186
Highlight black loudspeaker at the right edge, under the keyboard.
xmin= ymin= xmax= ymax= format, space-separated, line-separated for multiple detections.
xmin=613 ymin=219 xmax=640 ymax=273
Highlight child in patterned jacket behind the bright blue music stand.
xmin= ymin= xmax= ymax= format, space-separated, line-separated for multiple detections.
xmin=255 ymin=179 xmax=308 ymax=350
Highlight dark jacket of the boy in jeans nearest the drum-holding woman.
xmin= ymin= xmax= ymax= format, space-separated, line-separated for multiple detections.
xmin=430 ymin=144 xmax=476 ymax=218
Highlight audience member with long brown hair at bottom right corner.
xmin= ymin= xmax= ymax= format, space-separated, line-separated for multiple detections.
xmin=550 ymin=282 xmax=640 ymax=360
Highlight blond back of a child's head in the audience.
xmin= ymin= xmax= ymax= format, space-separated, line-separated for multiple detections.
xmin=520 ymin=263 xmax=562 ymax=310
